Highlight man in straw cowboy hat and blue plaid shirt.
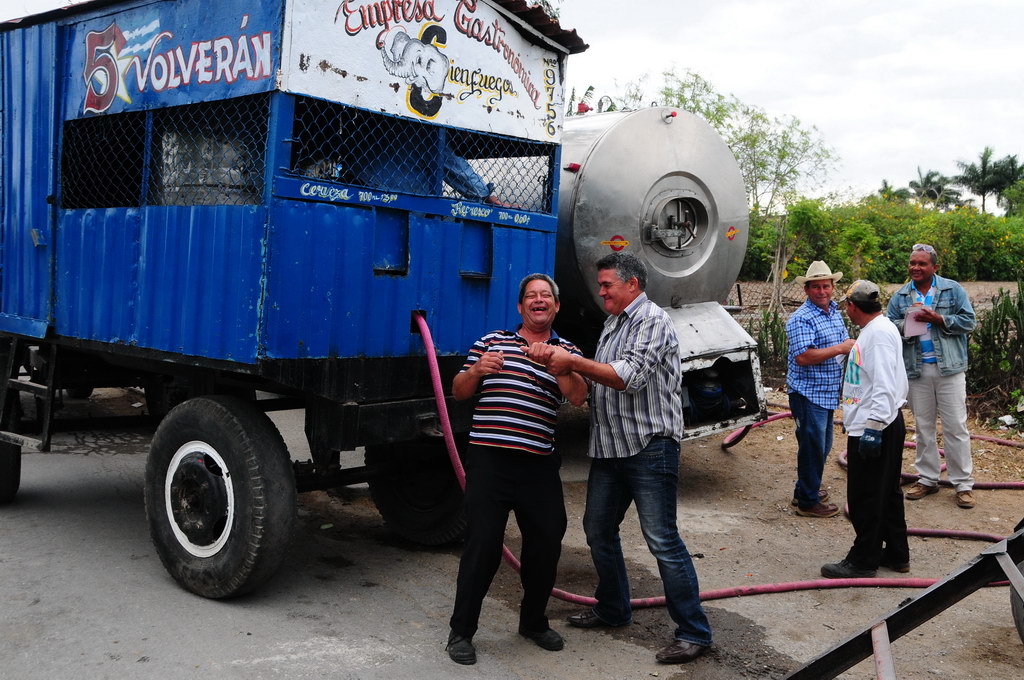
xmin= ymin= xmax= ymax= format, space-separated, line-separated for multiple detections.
xmin=785 ymin=260 xmax=853 ymax=517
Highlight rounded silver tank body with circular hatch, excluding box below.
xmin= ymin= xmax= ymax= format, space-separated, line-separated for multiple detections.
xmin=555 ymin=107 xmax=748 ymax=319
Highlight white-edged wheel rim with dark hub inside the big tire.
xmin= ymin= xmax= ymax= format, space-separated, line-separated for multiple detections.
xmin=164 ymin=441 xmax=234 ymax=557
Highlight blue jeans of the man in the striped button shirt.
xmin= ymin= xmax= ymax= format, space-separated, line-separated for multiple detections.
xmin=583 ymin=437 xmax=711 ymax=645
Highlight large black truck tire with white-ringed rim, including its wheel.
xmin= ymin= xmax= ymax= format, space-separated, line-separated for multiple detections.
xmin=145 ymin=395 xmax=296 ymax=598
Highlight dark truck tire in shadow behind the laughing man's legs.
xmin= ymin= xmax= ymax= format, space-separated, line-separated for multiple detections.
xmin=366 ymin=439 xmax=466 ymax=546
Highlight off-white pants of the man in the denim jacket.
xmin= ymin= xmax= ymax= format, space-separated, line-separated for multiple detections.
xmin=907 ymin=364 xmax=974 ymax=492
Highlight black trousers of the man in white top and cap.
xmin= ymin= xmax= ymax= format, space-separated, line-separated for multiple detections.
xmin=846 ymin=412 xmax=910 ymax=569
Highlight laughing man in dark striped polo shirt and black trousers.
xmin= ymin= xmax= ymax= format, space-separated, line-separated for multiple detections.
xmin=447 ymin=273 xmax=587 ymax=665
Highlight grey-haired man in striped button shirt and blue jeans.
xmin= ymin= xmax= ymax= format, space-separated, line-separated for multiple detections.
xmin=546 ymin=252 xmax=712 ymax=664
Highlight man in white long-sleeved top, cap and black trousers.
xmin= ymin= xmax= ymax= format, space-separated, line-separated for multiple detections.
xmin=821 ymin=281 xmax=910 ymax=579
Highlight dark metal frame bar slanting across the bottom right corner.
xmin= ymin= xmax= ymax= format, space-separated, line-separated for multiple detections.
xmin=785 ymin=528 xmax=1024 ymax=680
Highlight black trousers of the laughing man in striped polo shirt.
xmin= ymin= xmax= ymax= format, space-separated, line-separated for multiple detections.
xmin=451 ymin=445 xmax=566 ymax=637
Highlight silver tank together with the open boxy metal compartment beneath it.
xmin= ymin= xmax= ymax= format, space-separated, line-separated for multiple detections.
xmin=555 ymin=108 xmax=765 ymax=438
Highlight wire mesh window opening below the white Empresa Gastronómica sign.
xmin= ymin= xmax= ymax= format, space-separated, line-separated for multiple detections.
xmin=291 ymin=97 xmax=557 ymax=213
